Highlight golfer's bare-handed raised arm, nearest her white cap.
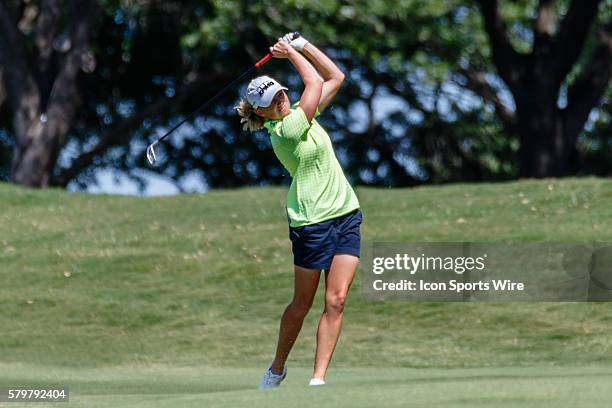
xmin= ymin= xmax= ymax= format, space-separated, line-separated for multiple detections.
xmin=270 ymin=41 xmax=323 ymax=122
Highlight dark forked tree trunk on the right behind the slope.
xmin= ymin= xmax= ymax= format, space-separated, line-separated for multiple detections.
xmin=476 ymin=0 xmax=612 ymax=177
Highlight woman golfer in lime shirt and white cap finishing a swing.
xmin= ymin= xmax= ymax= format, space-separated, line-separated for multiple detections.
xmin=236 ymin=34 xmax=362 ymax=389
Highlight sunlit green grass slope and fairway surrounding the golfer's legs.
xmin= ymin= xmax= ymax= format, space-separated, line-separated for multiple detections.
xmin=0 ymin=178 xmax=612 ymax=408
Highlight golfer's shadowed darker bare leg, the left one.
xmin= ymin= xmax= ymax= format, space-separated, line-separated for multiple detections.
xmin=272 ymin=266 xmax=321 ymax=374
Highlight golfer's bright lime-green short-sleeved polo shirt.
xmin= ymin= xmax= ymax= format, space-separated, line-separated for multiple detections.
xmin=264 ymin=102 xmax=359 ymax=227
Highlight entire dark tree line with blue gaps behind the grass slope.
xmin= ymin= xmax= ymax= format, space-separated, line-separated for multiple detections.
xmin=0 ymin=0 xmax=612 ymax=191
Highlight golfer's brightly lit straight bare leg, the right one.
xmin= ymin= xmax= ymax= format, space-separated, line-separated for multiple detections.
xmin=313 ymin=254 xmax=359 ymax=380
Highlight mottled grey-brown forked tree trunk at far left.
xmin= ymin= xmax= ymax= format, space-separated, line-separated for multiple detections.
xmin=0 ymin=0 xmax=94 ymax=186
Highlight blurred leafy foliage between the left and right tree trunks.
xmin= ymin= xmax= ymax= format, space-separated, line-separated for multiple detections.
xmin=0 ymin=0 xmax=612 ymax=187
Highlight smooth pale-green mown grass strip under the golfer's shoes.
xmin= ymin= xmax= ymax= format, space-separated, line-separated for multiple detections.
xmin=0 ymin=365 xmax=612 ymax=408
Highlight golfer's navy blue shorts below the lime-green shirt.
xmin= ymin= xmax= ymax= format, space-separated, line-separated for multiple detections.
xmin=289 ymin=209 xmax=362 ymax=269
